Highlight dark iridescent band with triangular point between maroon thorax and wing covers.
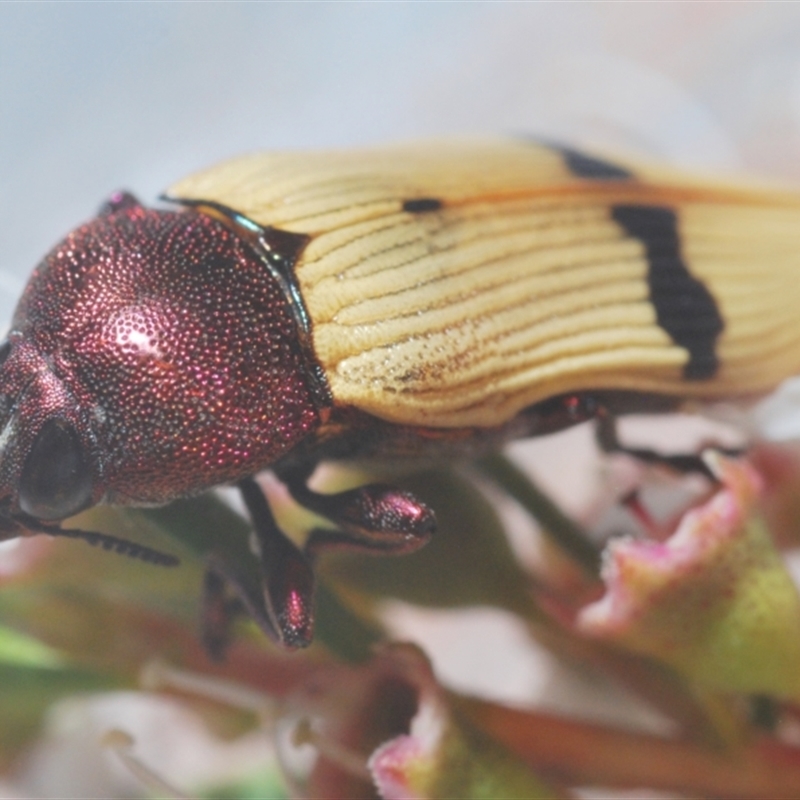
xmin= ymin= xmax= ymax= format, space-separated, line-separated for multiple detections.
xmin=161 ymin=195 xmax=333 ymax=407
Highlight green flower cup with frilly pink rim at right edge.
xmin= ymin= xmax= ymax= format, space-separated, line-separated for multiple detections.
xmin=577 ymin=453 xmax=800 ymax=698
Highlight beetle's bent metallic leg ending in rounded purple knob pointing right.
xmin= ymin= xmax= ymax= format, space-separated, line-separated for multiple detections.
xmin=281 ymin=469 xmax=436 ymax=555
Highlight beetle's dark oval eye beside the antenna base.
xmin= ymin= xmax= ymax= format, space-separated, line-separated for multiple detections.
xmin=19 ymin=419 xmax=92 ymax=520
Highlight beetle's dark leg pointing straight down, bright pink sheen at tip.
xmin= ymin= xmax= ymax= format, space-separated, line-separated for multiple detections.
xmin=234 ymin=478 xmax=314 ymax=648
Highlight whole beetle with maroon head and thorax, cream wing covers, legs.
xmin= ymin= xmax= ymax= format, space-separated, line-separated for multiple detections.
xmin=0 ymin=142 xmax=800 ymax=649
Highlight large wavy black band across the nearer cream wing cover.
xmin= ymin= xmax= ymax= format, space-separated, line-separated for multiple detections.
xmin=611 ymin=205 xmax=725 ymax=381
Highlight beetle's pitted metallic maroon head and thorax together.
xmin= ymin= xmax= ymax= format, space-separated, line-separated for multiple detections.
xmin=0 ymin=191 xmax=318 ymax=527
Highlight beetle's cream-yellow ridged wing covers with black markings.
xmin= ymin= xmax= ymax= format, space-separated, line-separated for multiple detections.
xmin=169 ymin=143 xmax=800 ymax=427
